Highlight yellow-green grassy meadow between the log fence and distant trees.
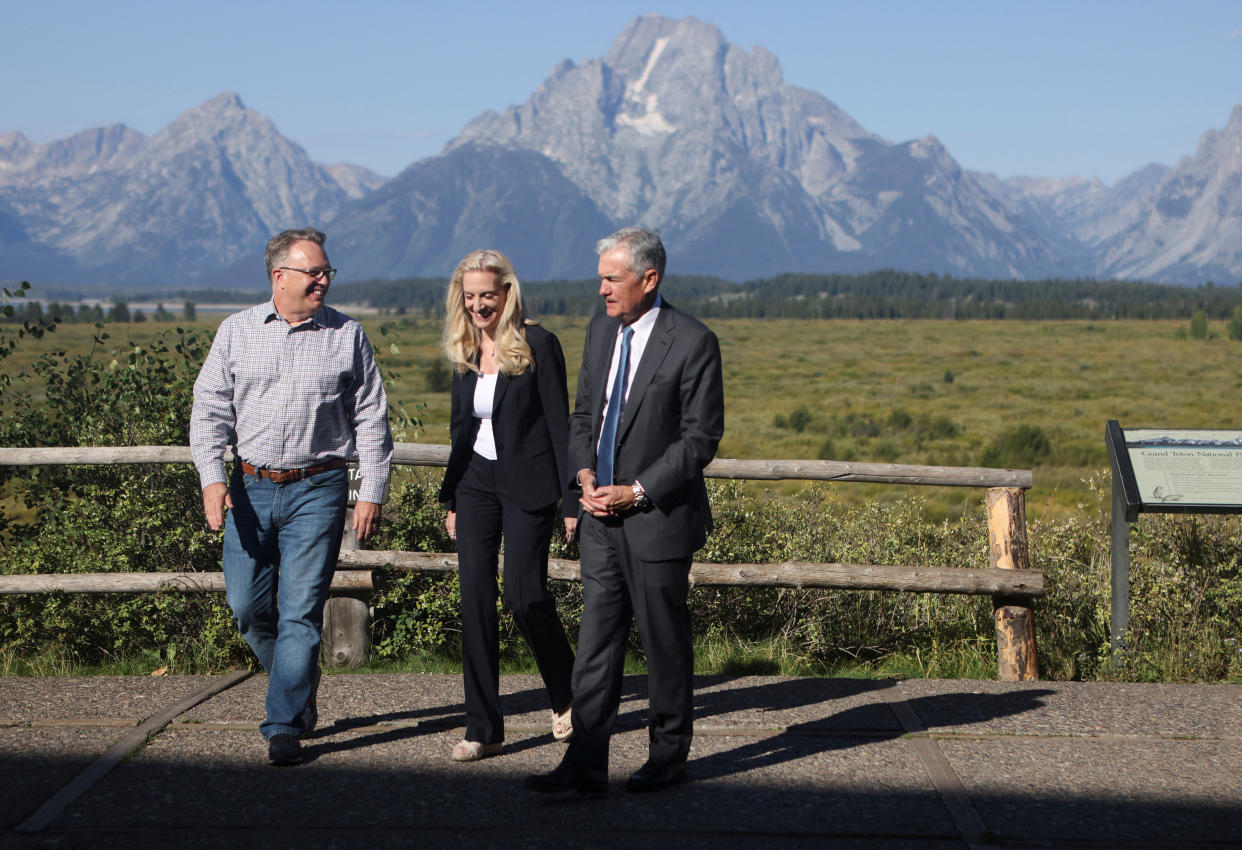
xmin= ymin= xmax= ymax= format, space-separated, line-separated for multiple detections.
xmin=4 ymin=308 xmax=1242 ymax=518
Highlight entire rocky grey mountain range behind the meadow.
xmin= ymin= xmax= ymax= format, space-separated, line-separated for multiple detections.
xmin=0 ymin=15 xmax=1242 ymax=287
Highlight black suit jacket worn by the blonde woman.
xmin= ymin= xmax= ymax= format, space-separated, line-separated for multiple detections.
xmin=440 ymin=324 xmax=579 ymax=517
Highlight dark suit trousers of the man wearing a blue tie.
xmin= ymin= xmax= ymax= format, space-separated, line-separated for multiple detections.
xmin=565 ymin=514 xmax=694 ymax=770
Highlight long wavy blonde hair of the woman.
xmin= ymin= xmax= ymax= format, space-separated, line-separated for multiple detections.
xmin=443 ymin=250 xmax=538 ymax=375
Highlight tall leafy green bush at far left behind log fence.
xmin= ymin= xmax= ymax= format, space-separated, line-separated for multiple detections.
xmin=0 ymin=326 xmax=248 ymax=669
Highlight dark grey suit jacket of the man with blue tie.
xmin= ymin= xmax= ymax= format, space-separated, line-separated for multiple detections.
xmin=569 ymin=301 xmax=724 ymax=560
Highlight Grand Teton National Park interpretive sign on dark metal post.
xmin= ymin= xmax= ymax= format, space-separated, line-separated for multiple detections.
xmin=1104 ymin=419 xmax=1242 ymax=650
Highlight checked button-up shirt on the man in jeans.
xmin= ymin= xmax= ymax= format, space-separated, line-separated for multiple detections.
xmin=190 ymin=301 xmax=392 ymax=503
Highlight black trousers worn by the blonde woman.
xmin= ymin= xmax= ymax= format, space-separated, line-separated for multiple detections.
xmin=456 ymin=454 xmax=574 ymax=743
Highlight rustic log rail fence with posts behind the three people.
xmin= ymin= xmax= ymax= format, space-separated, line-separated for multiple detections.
xmin=0 ymin=442 xmax=1043 ymax=681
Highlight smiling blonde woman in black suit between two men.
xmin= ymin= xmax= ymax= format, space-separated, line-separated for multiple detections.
xmin=440 ymin=251 xmax=579 ymax=762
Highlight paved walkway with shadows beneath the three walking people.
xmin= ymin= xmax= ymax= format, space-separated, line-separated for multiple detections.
xmin=0 ymin=675 xmax=1242 ymax=850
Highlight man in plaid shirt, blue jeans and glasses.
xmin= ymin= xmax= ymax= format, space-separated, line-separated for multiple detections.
xmin=190 ymin=227 xmax=392 ymax=765
